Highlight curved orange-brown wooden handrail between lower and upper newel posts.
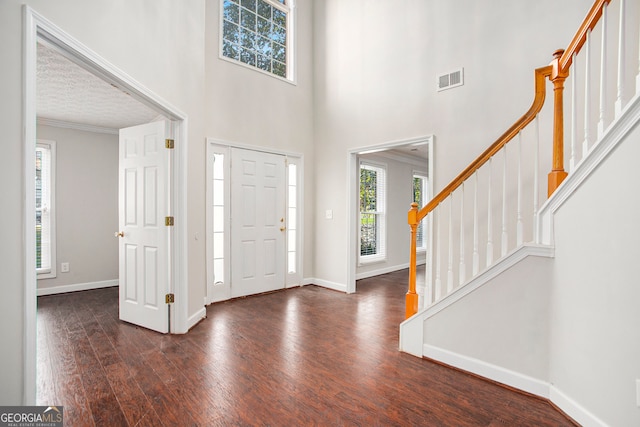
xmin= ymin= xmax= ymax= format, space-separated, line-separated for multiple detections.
xmin=416 ymin=65 xmax=552 ymax=226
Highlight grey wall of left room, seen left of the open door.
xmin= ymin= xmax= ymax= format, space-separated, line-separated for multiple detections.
xmin=37 ymin=126 xmax=118 ymax=289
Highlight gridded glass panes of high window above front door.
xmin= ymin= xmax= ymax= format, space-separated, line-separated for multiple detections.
xmin=221 ymin=0 xmax=293 ymax=80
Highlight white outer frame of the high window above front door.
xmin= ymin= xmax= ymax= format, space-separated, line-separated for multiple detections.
xmin=218 ymin=0 xmax=297 ymax=84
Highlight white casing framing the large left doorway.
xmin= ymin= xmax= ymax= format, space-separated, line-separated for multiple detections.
xmin=23 ymin=6 xmax=188 ymax=405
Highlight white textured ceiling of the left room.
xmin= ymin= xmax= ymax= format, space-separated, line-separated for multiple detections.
xmin=36 ymin=44 xmax=159 ymax=129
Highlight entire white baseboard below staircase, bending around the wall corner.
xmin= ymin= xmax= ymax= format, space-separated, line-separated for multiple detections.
xmin=422 ymin=344 xmax=607 ymax=427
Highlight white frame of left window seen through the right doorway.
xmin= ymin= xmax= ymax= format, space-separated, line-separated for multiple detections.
xmin=358 ymin=160 xmax=387 ymax=265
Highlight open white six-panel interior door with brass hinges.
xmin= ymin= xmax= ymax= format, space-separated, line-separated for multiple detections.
xmin=118 ymin=121 xmax=171 ymax=333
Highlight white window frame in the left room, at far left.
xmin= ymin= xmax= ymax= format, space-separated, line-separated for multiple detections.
xmin=34 ymin=139 xmax=57 ymax=279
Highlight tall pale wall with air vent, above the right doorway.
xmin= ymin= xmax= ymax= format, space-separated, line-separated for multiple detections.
xmin=314 ymin=0 xmax=591 ymax=290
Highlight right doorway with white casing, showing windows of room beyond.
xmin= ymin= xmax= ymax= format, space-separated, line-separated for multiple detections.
xmin=347 ymin=136 xmax=434 ymax=293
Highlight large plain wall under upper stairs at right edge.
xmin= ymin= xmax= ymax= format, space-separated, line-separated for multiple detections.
xmin=550 ymin=124 xmax=640 ymax=426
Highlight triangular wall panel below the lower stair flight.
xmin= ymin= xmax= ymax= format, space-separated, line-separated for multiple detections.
xmin=423 ymin=252 xmax=553 ymax=382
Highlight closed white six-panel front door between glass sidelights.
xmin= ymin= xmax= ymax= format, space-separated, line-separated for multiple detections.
xmin=231 ymin=148 xmax=286 ymax=298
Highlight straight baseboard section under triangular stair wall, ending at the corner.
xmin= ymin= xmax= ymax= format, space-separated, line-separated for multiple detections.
xmin=422 ymin=344 xmax=550 ymax=399
